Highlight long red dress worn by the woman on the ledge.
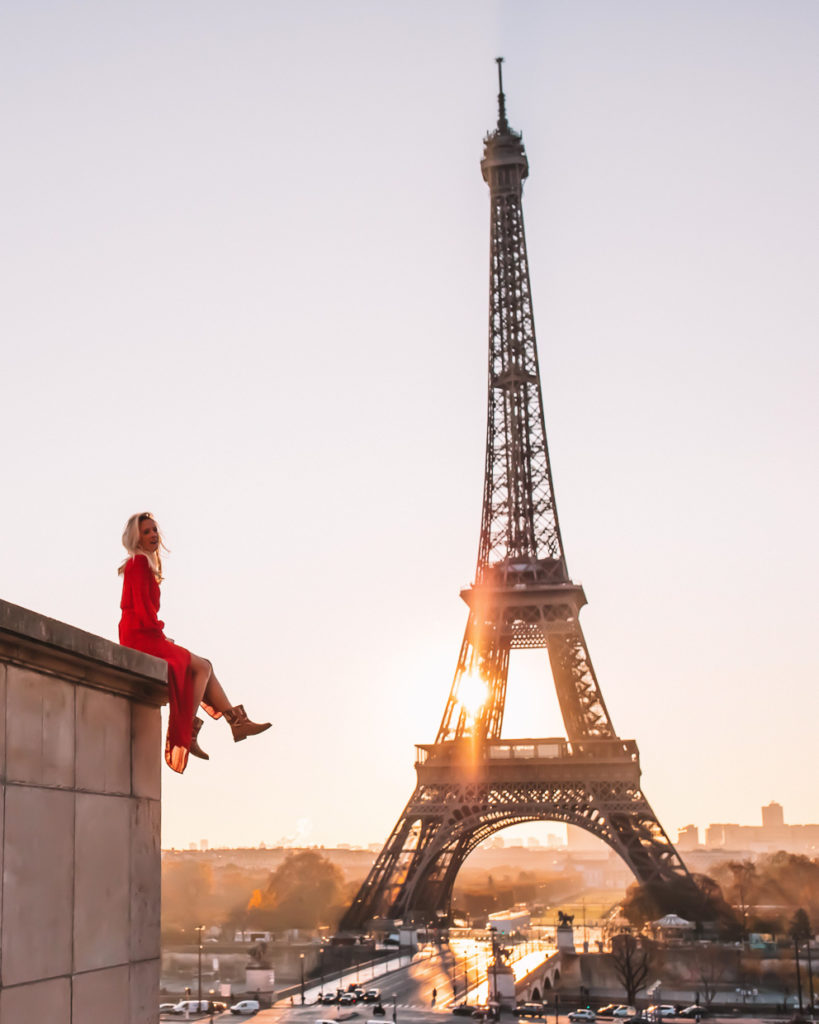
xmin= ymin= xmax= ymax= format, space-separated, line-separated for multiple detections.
xmin=120 ymin=555 xmax=221 ymax=772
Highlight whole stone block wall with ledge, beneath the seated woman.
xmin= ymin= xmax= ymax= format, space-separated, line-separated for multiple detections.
xmin=0 ymin=601 xmax=167 ymax=1024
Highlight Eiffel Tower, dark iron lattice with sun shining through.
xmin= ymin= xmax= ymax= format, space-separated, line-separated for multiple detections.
xmin=340 ymin=57 xmax=693 ymax=932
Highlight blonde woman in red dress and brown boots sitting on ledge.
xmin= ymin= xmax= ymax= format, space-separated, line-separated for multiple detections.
xmin=119 ymin=512 xmax=270 ymax=772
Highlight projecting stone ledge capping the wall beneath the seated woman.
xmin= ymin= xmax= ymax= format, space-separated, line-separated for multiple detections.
xmin=0 ymin=600 xmax=168 ymax=706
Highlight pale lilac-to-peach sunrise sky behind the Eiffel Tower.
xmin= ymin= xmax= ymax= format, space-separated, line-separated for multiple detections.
xmin=0 ymin=0 xmax=819 ymax=846
